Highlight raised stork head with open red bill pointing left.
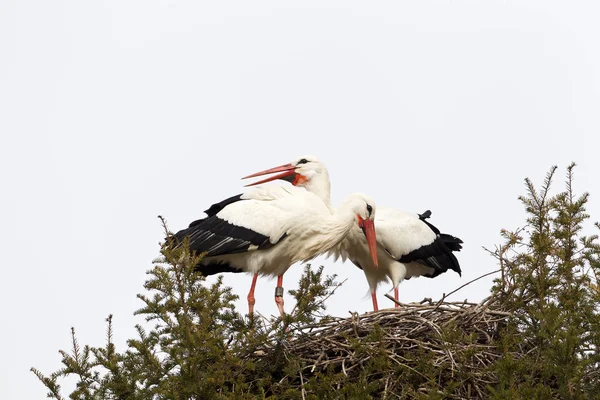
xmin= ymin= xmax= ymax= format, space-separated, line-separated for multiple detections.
xmin=242 ymin=156 xmax=330 ymax=203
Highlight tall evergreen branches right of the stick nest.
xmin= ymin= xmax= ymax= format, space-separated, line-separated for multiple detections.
xmin=492 ymin=164 xmax=600 ymax=399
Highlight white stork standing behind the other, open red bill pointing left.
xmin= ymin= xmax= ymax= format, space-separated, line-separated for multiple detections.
xmin=242 ymin=156 xmax=463 ymax=311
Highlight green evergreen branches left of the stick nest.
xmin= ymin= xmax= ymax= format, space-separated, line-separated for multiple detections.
xmin=32 ymin=218 xmax=339 ymax=399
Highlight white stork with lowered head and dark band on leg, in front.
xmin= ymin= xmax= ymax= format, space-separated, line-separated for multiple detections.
xmin=169 ymin=186 xmax=377 ymax=316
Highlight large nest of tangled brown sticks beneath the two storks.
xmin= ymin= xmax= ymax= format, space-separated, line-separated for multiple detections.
xmin=260 ymin=297 xmax=510 ymax=399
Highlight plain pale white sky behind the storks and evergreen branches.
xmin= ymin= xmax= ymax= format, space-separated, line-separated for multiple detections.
xmin=0 ymin=0 xmax=600 ymax=399
